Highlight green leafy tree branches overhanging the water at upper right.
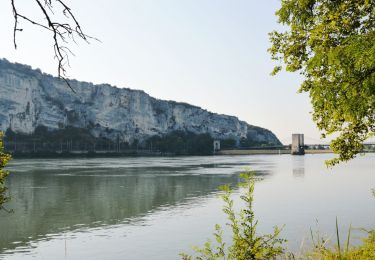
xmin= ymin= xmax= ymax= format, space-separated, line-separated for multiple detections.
xmin=269 ymin=0 xmax=375 ymax=166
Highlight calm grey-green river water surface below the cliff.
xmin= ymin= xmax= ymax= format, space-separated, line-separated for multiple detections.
xmin=0 ymin=154 xmax=375 ymax=259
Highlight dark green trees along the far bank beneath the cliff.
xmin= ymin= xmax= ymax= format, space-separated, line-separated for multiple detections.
xmin=0 ymin=126 xmax=272 ymax=156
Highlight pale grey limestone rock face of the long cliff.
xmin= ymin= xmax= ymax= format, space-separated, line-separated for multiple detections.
xmin=0 ymin=59 xmax=280 ymax=145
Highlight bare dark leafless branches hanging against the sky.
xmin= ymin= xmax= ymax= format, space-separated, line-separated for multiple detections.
xmin=11 ymin=0 xmax=98 ymax=91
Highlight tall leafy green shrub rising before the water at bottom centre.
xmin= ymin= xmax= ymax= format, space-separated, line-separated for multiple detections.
xmin=181 ymin=173 xmax=286 ymax=260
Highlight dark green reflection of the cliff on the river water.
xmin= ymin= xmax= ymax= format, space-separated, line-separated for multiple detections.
xmin=0 ymin=156 xmax=270 ymax=252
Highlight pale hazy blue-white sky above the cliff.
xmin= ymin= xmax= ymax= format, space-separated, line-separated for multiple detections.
xmin=0 ymin=0 xmax=328 ymax=143
